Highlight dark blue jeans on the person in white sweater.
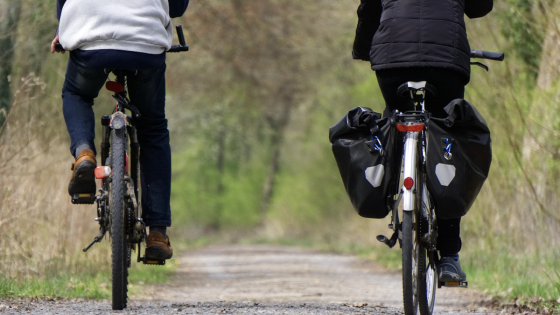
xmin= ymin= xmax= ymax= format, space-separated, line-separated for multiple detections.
xmin=62 ymin=53 xmax=171 ymax=226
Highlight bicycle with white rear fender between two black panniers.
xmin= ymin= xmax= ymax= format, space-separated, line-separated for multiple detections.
xmin=377 ymin=50 xmax=504 ymax=315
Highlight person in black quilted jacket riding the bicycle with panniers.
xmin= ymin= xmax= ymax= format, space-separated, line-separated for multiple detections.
xmin=352 ymin=0 xmax=493 ymax=282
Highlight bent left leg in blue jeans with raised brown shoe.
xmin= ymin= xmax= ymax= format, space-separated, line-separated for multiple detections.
xmin=62 ymin=52 xmax=107 ymax=196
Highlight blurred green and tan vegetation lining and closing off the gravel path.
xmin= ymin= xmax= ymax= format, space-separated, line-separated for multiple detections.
xmin=0 ymin=0 xmax=560 ymax=307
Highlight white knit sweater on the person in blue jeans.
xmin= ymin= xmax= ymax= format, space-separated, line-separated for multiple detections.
xmin=59 ymin=0 xmax=172 ymax=54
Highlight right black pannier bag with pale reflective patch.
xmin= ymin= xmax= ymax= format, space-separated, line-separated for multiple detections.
xmin=426 ymin=99 xmax=492 ymax=219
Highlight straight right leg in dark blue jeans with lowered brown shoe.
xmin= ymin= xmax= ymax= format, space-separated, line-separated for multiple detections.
xmin=128 ymin=63 xmax=173 ymax=260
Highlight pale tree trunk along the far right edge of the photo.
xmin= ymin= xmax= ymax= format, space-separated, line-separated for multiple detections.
xmin=521 ymin=1 xmax=560 ymax=222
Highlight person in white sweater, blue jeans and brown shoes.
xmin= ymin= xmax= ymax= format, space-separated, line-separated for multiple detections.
xmin=51 ymin=0 xmax=189 ymax=260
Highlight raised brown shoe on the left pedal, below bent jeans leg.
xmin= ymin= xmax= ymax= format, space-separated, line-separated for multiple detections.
xmin=68 ymin=149 xmax=97 ymax=196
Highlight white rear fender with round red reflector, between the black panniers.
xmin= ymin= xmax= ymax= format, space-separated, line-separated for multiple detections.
xmin=402 ymin=132 xmax=420 ymax=211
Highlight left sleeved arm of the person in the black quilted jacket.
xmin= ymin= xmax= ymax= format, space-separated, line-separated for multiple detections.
xmin=352 ymin=0 xmax=382 ymax=61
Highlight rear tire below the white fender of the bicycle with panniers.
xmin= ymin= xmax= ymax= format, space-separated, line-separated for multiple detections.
xmin=402 ymin=211 xmax=418 ymax=315
